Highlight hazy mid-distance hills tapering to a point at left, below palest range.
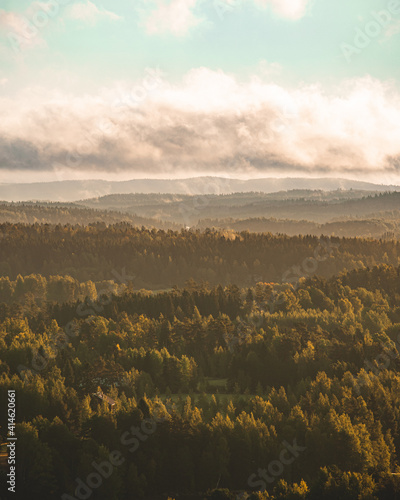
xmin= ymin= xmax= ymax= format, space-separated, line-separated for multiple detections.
xmin=79 ymin=190 xmax=400 ymax=226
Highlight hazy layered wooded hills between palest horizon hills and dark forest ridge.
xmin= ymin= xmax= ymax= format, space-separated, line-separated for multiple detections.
xmin=0 ymin=190 xmax=400 ymax=238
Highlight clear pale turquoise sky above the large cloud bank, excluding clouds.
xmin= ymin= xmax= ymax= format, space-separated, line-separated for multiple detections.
xmin=1 ymin=0 xmax=400 ymax=89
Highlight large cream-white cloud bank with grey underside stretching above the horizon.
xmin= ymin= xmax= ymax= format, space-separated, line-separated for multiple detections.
xmin=0 ymin=68 xmax=400 ymax=181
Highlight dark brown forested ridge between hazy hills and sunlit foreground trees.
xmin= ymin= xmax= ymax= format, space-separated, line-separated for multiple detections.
xmin=0 ymin=223 xmax=400 ymax=289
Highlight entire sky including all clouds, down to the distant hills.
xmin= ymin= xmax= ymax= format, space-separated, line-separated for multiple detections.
xmin=0 ymin=0 xmax=400 ymax=183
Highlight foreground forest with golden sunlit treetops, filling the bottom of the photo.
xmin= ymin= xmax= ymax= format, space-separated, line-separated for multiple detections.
xmin=0 ymin=265 xmax=400 ymax=500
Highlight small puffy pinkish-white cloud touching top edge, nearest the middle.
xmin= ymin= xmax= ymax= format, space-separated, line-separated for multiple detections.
xmin=141 ymin=0 xmax=203 ymax=36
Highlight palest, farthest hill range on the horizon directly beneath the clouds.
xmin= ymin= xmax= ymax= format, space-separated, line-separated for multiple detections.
xmin=0 ymin=177 xmax=400 ymax=202
